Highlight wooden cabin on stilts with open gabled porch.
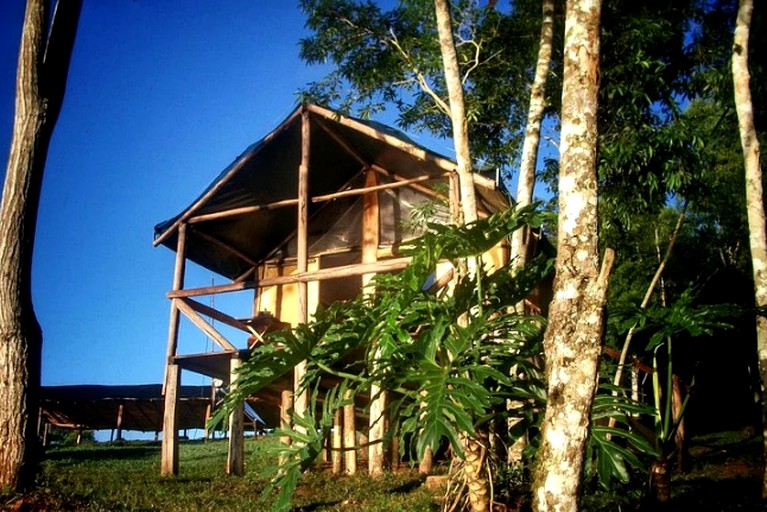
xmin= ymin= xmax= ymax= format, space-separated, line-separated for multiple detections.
xmin=154 ymin=105 xmax=524 ymax=475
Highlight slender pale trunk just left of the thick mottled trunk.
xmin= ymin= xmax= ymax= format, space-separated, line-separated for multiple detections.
xmin=511 ymin=0 xmax=554 ymax=268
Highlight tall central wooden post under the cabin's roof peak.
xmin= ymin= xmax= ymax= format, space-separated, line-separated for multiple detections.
xmin=293 ymin=111 xmax=311 ymax=430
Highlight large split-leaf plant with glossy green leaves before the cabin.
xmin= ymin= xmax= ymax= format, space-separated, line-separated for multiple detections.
xmin=211 ymin=207 xmax=660 ymax=511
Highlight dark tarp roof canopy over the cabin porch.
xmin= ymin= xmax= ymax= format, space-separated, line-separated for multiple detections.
xmin=154 ymin=105 xmax=508 ymax=279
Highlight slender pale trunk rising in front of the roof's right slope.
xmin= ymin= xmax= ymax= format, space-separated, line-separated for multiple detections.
xmin=434 ymin=0 xmax=477 ymax=224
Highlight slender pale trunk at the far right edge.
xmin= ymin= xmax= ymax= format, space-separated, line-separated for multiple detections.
xmin=732 ymin=0 xmax=767 ymax=499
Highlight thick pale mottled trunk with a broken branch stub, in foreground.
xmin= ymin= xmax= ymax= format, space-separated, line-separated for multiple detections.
xmin=532 ymin=0 xmax=613 ymax=512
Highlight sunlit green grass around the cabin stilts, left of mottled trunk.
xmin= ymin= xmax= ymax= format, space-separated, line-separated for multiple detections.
xmin=0 ymin=438 xmax=439 ymax=512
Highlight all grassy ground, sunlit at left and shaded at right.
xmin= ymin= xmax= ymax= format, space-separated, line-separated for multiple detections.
xmin=0 ymin=431 xmax=763 ymax=512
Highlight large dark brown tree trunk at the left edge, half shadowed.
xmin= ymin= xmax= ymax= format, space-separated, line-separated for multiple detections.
xmin=0 ymin=0 xmax=82 ymax=490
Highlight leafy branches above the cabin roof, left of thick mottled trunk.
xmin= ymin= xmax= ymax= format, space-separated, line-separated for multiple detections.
xmin=301 ymin=0 xmax=562 ymax=174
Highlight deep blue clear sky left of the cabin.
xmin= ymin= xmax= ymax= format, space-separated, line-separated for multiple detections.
xmin=0 ymin=0 xmax=464 ymax=392
